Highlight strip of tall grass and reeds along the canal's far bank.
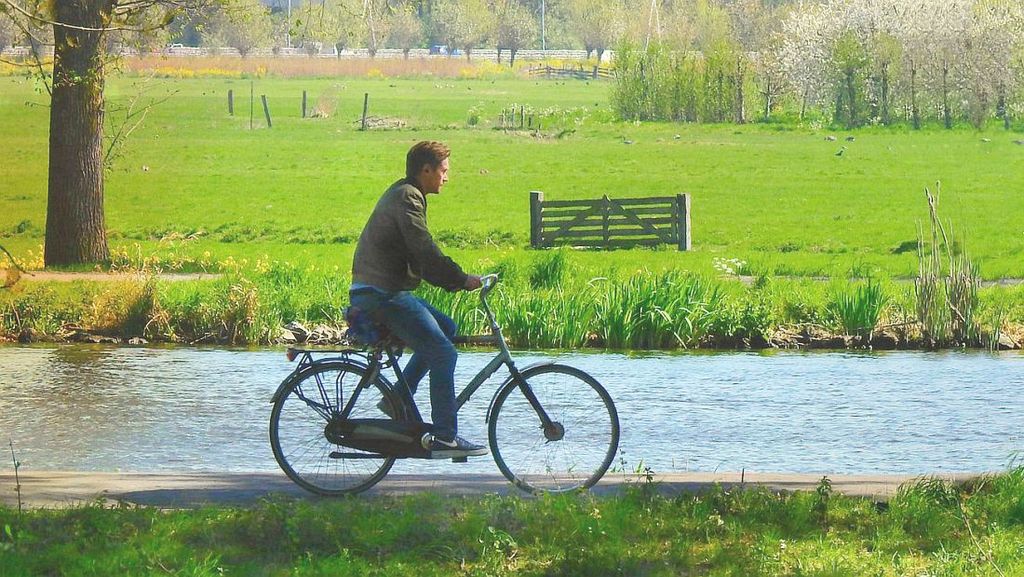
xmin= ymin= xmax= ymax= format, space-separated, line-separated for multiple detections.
xmin=0 ymin=250 xmax=1024 ymax=349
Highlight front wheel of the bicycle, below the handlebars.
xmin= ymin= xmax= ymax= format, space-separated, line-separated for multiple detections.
xmin=487 ymin=365 xmax=618 ymax=493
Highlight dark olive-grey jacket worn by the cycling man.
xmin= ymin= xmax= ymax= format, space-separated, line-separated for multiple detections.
xmin=352 ymin=178 xmax=467 ymax=292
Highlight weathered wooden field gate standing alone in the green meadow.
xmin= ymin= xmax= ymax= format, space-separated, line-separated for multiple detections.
xmin=529 ymin=192 xmax=690 ymax=250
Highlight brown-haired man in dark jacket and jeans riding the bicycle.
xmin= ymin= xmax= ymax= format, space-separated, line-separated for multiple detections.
xmin=349 ymin=140 xmax=487 ymax=457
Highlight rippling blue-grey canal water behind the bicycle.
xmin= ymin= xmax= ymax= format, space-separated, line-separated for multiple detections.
xmin=0 ymin=345 xmax=1024 ymax=475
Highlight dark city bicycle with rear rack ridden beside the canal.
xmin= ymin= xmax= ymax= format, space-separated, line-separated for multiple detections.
xmin=270 ymin=275 xmax=620 ymax=496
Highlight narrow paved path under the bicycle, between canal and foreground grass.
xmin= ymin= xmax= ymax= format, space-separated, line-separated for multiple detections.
xmin=0 ymin=471 xmax=971 ymax=508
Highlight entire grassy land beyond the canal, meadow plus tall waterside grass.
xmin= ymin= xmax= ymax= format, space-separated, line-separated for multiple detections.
xmin=0 ymin=70 xmax=1024 ymax=348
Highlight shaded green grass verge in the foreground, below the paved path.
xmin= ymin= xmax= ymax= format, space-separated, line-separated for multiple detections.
xmin=0 ymin=468 xmax=1024 ymax=577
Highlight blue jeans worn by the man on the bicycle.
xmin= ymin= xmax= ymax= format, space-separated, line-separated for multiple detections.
xmin=349 ymin=289 xmax=459 ymax=440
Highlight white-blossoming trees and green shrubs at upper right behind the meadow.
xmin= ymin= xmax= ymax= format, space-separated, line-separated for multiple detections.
xmin=612 ymin=0 xmax=1024 ymax=129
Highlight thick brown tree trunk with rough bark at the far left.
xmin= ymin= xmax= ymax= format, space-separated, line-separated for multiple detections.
xmin=44 ymin=0 xmax=112 ymax=266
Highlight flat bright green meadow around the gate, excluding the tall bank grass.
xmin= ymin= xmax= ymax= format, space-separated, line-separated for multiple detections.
xmin=0 ymin=76 xmax=1024 ymax=279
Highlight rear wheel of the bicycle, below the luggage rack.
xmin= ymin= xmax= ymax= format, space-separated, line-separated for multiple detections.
xmin=270 ymin=362 xmax=398 ymax=496
